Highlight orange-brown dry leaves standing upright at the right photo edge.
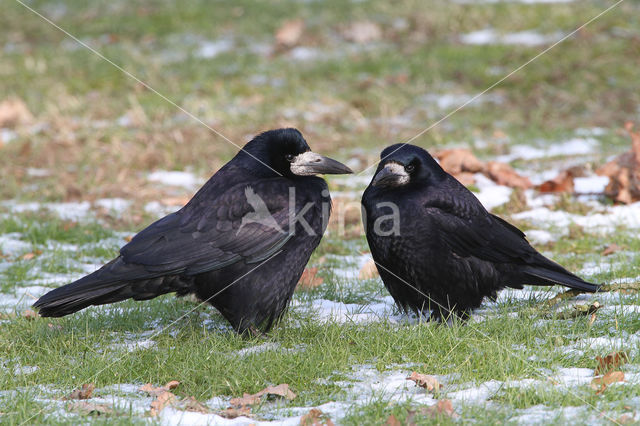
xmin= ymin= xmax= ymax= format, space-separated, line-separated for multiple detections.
xmin=596 ymin=122 xmax=640 ymax=204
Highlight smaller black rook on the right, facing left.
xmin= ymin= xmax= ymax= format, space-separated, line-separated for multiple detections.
xmin=362 ymin=144 xmax=598 ymax=320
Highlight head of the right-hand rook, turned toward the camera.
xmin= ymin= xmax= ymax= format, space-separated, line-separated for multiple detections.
xmin=371 ymin=144 xmax=446 ymax=188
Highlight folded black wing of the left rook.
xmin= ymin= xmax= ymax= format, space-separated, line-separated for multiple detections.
xmin=120 ymin=178 xmax=291 ymax=275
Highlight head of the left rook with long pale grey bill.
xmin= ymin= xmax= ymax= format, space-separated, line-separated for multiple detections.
xmin=238 ymin=129 xmax=353 ymax=177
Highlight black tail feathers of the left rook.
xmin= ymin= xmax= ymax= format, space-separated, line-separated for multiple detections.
xmin=33 ymin=258 xmax=188 ymax=317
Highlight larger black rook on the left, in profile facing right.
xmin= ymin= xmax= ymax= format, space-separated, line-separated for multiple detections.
xmin=34 ymin=129 xmax=352 ymax=333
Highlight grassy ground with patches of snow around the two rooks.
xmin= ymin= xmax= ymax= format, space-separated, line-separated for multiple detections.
xmin=0 ymin=0 xmax=640 ymax=424
